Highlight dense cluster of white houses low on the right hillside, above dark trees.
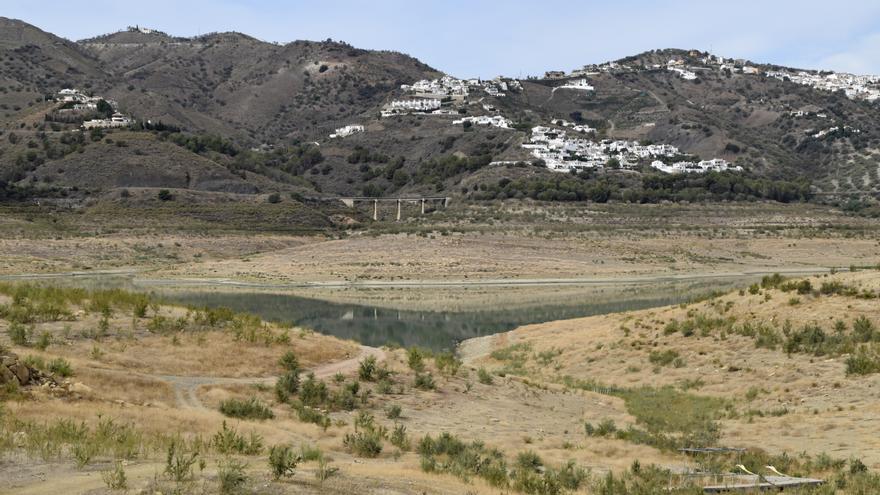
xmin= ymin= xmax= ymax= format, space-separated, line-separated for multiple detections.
xmin=523 ymin=126 xmax=742 ymax=173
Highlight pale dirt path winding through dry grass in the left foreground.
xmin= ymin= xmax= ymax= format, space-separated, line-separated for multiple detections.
xmin=156 ymin=345 xmax=385 ymax=411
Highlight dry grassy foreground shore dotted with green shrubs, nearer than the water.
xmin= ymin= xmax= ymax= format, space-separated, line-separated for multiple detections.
xmin=0 ymin=270 xmax=880 ymax=494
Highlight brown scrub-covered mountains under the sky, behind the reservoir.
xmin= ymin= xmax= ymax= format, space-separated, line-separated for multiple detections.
xmin=0 ymin=19 xmax=880 ymax=203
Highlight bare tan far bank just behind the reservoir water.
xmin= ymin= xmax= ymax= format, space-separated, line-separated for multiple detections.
xmin=148 ymin=234 xmax=878 ymax=284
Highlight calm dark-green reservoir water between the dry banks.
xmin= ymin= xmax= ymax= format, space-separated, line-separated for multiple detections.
xmin=163 ymin=279 xmax=748 ymax=350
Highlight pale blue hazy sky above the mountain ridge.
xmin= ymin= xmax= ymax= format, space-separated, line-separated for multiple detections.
xmin=0 ymin=0 xmax=880 ymax=77
